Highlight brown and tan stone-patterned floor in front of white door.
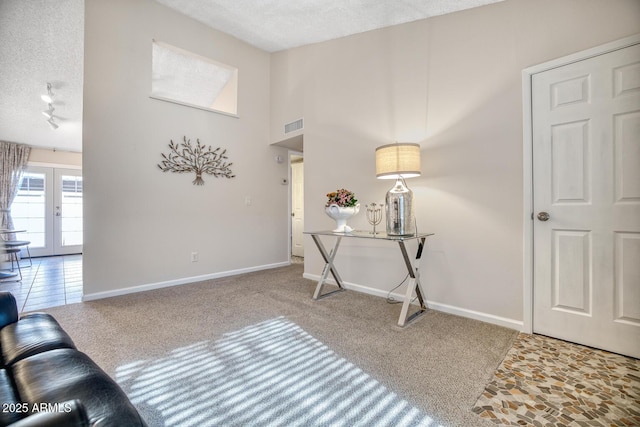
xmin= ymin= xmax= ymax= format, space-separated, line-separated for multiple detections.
xmin=472 ymin=334 xmax=640 ymax=427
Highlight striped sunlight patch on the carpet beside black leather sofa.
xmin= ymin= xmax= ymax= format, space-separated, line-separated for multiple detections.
xmin=116 ymin=317 xmax=435 ymax=427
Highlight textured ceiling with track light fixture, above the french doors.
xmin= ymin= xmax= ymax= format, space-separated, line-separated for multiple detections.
xmin=0 ymin=0 xmax=84 ymax=151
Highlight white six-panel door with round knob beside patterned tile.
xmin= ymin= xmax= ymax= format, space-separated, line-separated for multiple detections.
xmin=532 ymin=44 xmax=640 ymax=358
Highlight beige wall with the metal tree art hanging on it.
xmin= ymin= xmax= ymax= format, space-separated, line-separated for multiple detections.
xmin=83 ymin=0 xmax=288 ymax=299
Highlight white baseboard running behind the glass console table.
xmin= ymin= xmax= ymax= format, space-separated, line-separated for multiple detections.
xmin=303 ymin=273 xmax=524 ymax=332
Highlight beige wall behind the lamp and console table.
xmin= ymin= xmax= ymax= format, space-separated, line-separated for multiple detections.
xmin=270 ymin=0 xmax=640 ymax=328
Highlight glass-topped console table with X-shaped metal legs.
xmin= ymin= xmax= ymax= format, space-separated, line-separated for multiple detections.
xmin=304 ymin=230 xmax=434 ymax=327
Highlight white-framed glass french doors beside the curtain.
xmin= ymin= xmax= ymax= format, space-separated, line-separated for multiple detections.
xmin=11 ymin=166 xmax=82 ymax=256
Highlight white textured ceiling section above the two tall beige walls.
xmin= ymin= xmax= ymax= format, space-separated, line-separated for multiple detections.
xmin=156 ymin=0 xmax=503 ymax=52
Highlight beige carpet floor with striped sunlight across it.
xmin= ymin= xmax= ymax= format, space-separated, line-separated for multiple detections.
xmin=37 ymin=264 xmax=517 ymax=426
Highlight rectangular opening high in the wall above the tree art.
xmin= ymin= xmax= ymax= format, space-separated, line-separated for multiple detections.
xmin=150 ymin=40 xmax=238 ymax=117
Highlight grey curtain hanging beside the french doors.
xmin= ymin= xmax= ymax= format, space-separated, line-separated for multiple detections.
xmin=0 ymin=141 xmax=31 ymax=240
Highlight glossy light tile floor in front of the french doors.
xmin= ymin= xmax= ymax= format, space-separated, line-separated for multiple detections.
xmin=0 ymin=254 xmax=82 ymax=312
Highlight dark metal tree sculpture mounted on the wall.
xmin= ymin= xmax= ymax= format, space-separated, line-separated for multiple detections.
xmin=158 ymin=136 xmax=235 ymax=185
